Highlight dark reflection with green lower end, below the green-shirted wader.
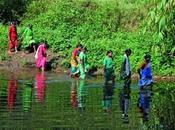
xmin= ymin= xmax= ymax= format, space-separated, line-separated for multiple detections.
xmin=102 ymin=83 xmax=114 ymax=112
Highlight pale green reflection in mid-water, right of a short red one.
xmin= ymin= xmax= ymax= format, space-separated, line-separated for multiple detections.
xmin=78 ymin=80 xmax=87 ymax=110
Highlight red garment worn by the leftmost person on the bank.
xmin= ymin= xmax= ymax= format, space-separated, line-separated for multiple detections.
xmin=9 ymin=25 xmax=18 ymax=50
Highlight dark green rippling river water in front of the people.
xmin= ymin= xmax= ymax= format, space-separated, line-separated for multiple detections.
xmin=0 ymin=72 xmax=165 ymax=130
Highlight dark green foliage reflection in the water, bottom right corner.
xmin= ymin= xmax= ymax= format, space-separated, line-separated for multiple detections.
xmin=148 ymin=83 xmax=175 ymax=130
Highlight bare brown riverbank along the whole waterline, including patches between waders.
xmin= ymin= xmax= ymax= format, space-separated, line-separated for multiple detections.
xmin=0 ymin=51 xmax=175 ymax=82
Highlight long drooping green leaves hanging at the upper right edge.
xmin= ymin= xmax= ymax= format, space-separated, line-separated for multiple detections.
xmin=147 ymin=0 xmax=175 ymax=68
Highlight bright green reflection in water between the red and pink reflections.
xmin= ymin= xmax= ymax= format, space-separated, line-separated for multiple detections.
xmin=23 ymin=83 xmax=33 ymax=112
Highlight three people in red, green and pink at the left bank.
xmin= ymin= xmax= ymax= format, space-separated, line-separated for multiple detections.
xmin=8 ymin=22 xmax=48 ymax=71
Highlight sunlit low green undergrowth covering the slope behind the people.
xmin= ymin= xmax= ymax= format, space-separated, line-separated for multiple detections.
xmin=22 ymin=0 xmax=165 ymax=74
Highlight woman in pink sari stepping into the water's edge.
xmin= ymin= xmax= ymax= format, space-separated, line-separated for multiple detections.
xmin=35 ymin=42 xmax=47 ymax=71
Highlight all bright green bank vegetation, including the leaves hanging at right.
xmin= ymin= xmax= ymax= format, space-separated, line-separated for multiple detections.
xmin=0 ymin=0 xmax=175 ymax=75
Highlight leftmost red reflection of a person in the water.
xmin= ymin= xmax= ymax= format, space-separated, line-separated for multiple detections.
xmin=8 ymin=77 xmax=18 ymax=110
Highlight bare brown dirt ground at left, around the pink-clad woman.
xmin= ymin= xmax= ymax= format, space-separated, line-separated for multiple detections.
xmin=0 ymin=51 xmax=62 ymax=72
